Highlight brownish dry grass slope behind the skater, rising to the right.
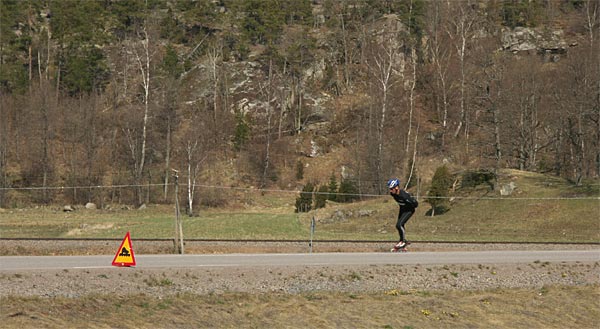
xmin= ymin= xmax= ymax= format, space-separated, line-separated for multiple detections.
xmin=304 ymin=170 xmax=600 ymax=242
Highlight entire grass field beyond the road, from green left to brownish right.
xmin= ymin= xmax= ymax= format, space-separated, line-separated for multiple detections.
xmin=0 ymin=171 xmax=600 ymax=242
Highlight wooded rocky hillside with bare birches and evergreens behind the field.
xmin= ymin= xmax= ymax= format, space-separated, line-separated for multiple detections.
xmin=0 ymin=0 xmax=600 ymax=214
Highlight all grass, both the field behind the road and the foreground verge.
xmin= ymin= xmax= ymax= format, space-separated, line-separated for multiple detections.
xmin=0 ymin=171 xmax=600 ymax=329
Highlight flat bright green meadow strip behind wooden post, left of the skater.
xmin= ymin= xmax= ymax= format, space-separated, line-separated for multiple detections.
xmin=0 ymin=206 xmax=308 ymax=239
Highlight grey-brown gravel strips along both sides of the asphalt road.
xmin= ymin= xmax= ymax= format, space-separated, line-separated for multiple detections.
xmin=0 ymin=240 xmax=600 ymax=297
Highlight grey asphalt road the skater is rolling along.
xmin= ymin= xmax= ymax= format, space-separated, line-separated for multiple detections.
xmin=0 ymin=249 xmax=600 ymax=272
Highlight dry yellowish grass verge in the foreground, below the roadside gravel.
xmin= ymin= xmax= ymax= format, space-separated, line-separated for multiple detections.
xmin=1 ymin=286 xmax=600 ymax=329
